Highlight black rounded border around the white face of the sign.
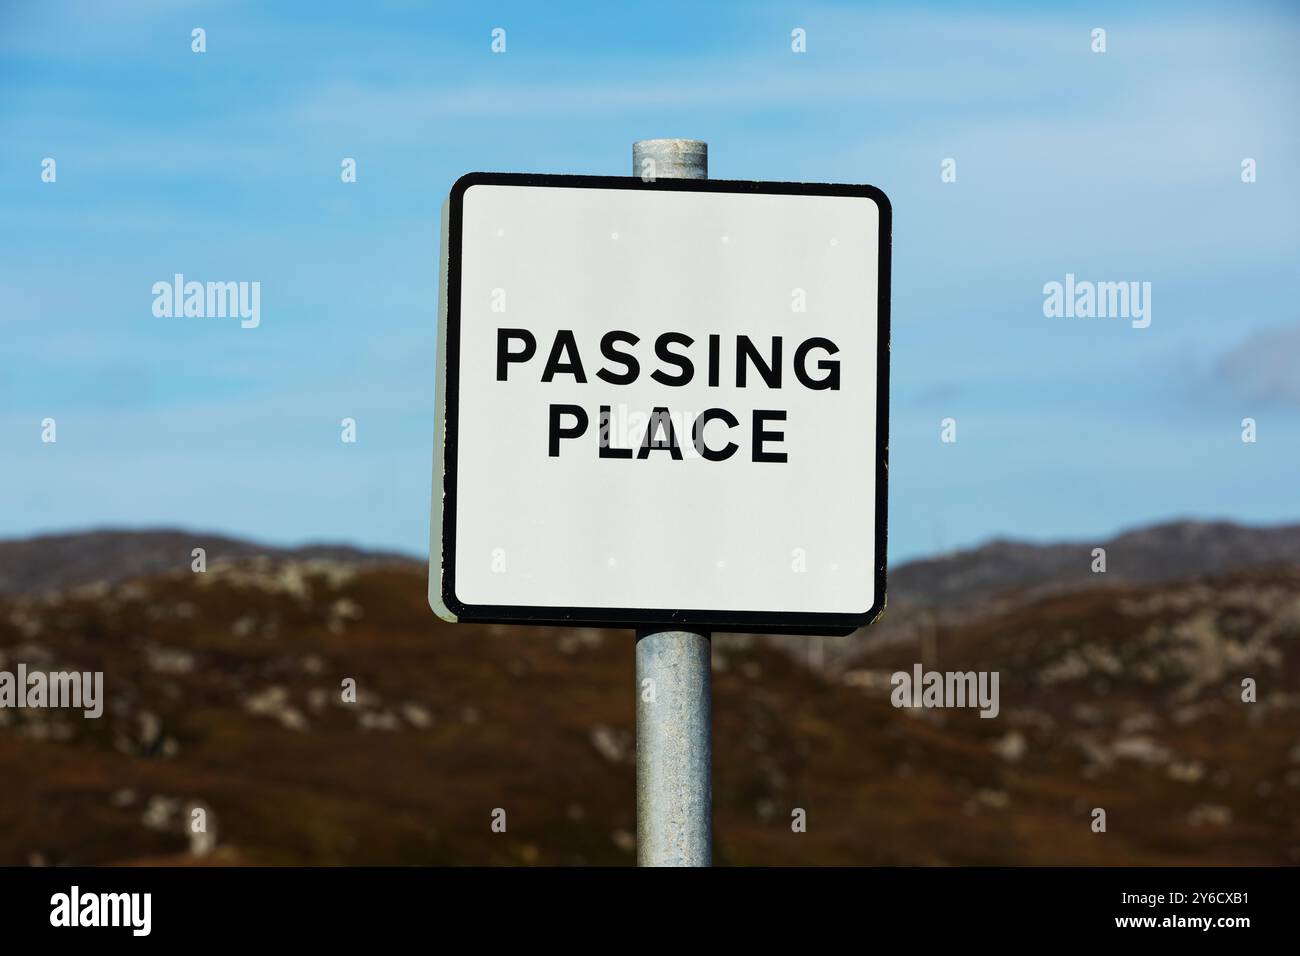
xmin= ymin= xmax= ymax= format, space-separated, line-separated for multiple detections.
xmin=434 ymin=173 xmax=893 ymax=635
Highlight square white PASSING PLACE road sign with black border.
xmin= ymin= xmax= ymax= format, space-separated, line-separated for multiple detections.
xmin=429 ymin=173 xmax=889 ymax=633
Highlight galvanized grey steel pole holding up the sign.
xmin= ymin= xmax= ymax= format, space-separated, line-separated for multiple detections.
xmin=632 ymin=139 xmax=714 ymax=866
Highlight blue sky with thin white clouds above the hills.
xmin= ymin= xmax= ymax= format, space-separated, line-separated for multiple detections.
xmin=0 ymin=1 xmax=1300 ymax=561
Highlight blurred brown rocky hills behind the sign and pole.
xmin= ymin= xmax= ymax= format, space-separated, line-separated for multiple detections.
xmin=0 ymin=522 xmax=1300 ymax=865
